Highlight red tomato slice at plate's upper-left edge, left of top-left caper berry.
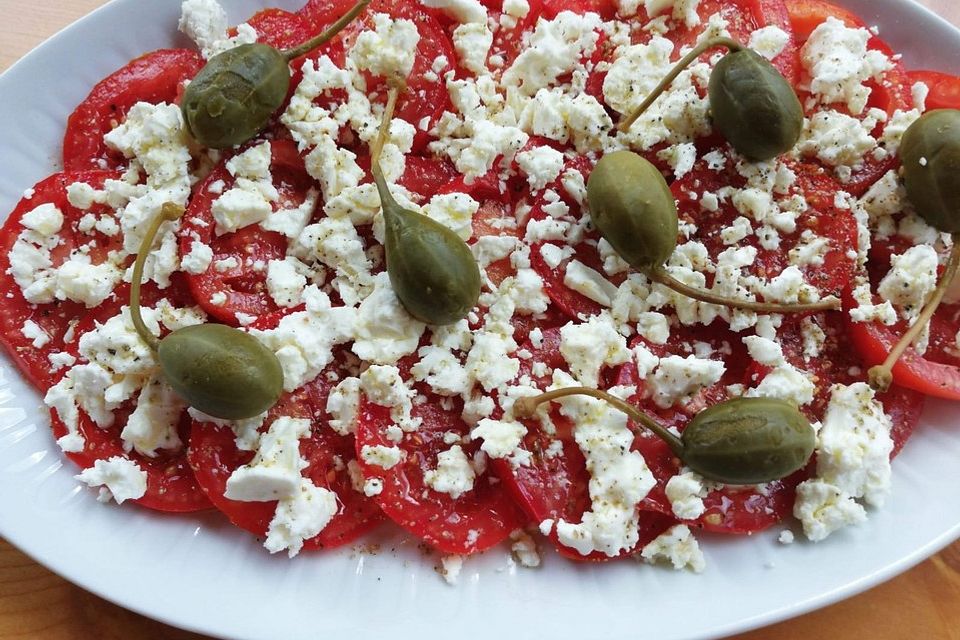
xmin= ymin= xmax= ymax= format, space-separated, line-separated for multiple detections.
xmin=63 ymin=49 xmax=204 ymax=171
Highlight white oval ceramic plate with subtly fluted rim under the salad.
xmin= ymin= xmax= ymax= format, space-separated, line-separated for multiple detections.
xmin=0 ymin=0 xmax=960 ymax=640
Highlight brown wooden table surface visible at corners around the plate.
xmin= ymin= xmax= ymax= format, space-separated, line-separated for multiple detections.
xmin=0 ymin=0 xmax=960 ymax=640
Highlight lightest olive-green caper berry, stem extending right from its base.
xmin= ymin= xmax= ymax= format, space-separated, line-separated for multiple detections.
xmin=587 ymin=151 xmax=839 ymax=313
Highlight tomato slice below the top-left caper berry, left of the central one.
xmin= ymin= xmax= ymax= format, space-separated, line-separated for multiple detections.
xmin=180 ymin=140 xmax=314 ymax=325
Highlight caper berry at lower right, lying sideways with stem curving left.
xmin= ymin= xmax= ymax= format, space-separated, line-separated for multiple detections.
xmin=513 ymin=387 xmax=816 ymax=484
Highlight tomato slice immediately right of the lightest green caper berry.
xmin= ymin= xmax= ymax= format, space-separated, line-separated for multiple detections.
xmin=671 ymin=159 xmax=857 ymax=304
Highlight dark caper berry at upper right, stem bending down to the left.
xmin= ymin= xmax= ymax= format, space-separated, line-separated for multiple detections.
xmin=619 ymin=38 xmax=803 ymax=161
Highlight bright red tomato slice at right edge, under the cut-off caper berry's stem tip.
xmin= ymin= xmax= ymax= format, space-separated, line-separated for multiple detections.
xmin=844 ymin=290 xmax=960 ymax=400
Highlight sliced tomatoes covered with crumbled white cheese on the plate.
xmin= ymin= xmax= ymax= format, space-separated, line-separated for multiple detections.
xmin=0 ymin=0 xmax=960 ymax=580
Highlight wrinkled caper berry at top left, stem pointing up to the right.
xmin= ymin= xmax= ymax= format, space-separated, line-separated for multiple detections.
xmin=180 ymin=0 xmax=370 ymax=149
